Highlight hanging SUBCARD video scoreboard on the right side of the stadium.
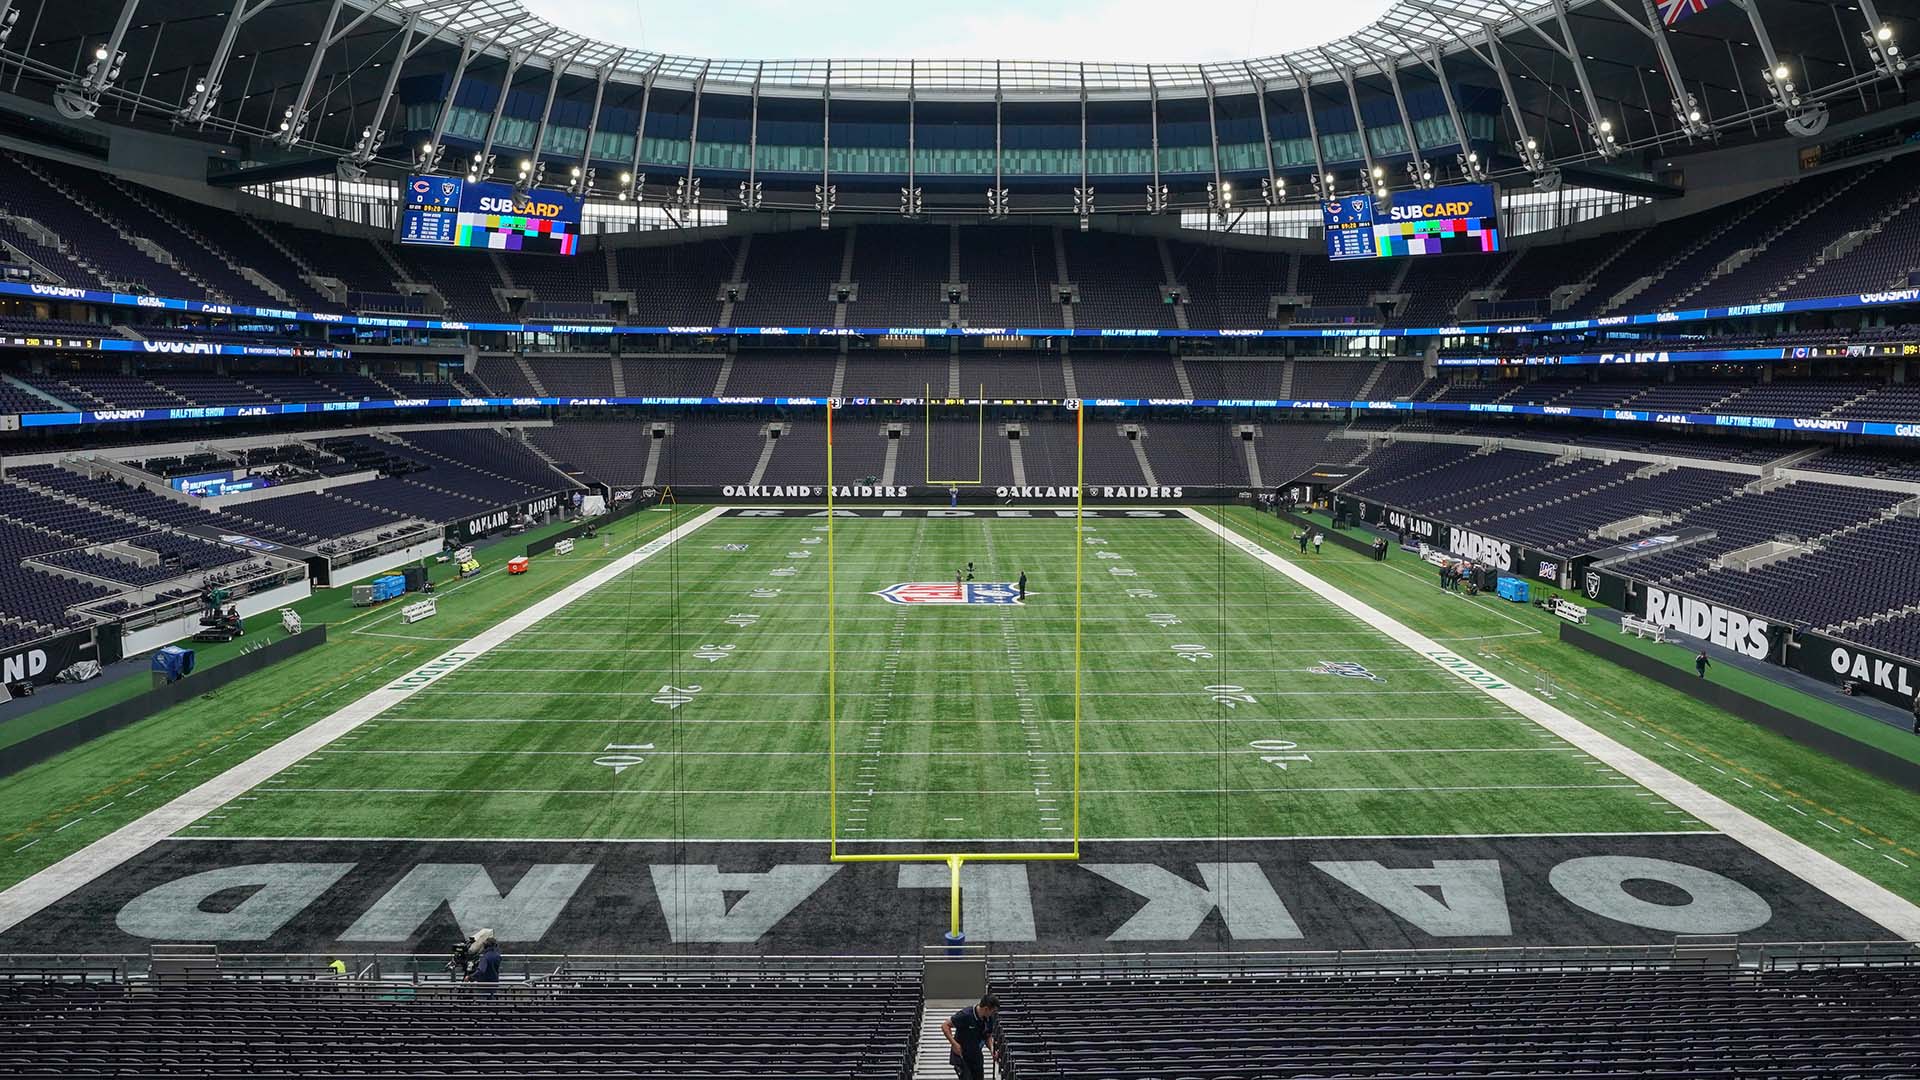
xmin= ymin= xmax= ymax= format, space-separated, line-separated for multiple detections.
xmin=1321 ymin=184 xmax=1501 ymax=259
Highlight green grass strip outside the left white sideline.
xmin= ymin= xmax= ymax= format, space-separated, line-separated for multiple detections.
xmin=0 ymin=513 xmax=698 ymax=886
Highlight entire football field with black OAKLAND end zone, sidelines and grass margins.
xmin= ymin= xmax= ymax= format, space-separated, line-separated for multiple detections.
xmin=0 ymin=505 xmax=1920 ymax=955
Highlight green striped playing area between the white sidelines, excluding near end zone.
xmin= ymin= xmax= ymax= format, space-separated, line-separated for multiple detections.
xmin=188 ymin=509 xmax=1705 ymax=851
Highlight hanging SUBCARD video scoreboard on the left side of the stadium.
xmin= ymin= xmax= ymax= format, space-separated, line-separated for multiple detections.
xmin=399 ymin=177 xmax=580 ymax=256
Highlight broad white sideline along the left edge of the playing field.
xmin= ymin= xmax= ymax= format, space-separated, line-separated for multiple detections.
xmin=0 ymin=507 xmax=726 ymax=934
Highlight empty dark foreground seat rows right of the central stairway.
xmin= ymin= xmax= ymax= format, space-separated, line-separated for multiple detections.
xmin=995 ymin=965 xmax=1920 ymax=1080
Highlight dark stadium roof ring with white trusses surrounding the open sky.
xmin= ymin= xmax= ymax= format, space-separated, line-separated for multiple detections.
xmin=15 ymin=0 xmax=1920 ymax=195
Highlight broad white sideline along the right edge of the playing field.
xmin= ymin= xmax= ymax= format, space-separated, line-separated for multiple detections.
xmin=1181 ymin=507 xmax=1920 ymax=942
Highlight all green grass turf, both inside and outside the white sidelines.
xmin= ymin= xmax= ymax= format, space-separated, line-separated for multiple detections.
xmin=11 ymin=509 xmax=1920 ymax=899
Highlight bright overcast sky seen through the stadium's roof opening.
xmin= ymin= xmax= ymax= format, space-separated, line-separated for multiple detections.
xmin=526 ymin=0 xmax=1388 ymax=61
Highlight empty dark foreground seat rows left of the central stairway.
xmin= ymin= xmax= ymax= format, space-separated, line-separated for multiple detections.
xmin=0 ymin=976 xmax=920 ymax=1080
